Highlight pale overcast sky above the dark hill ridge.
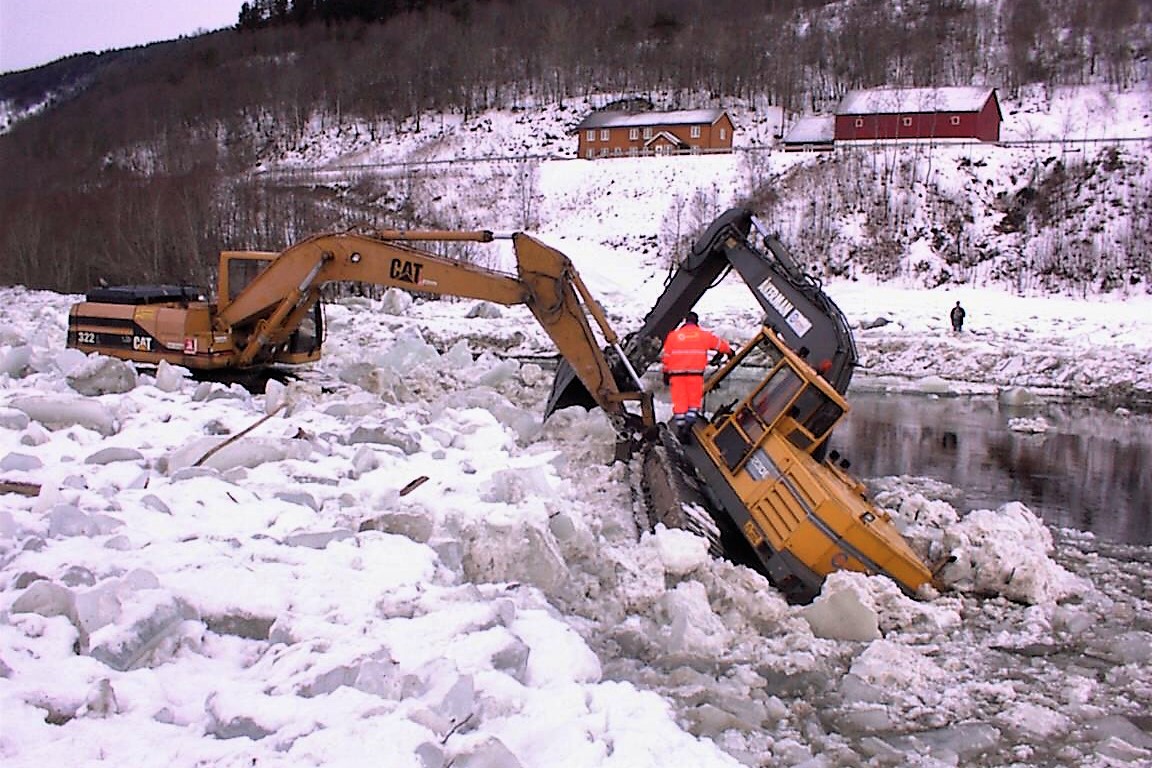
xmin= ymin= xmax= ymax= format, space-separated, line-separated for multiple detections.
xmin=0 ymin=0 xmax=243 ymax=73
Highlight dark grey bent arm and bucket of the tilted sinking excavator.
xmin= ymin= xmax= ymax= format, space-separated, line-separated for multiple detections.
xmin=546 ymin=207 xmax=857 ymax=413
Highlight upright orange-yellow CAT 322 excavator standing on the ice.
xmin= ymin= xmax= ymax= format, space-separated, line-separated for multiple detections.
xmin=67 ymin=230 xmax=654 ymax=444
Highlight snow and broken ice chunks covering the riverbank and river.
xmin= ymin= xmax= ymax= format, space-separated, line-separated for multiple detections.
xmin=0 ymin=247 xmax=1152 ymax=768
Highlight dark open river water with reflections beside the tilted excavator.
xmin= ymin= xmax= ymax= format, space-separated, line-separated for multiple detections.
xmin=832 ymin=390 xmax=1152 ymax=546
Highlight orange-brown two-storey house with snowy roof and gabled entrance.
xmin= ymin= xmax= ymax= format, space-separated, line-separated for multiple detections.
xmin=575 ymin=109 xmax=735 ymax=160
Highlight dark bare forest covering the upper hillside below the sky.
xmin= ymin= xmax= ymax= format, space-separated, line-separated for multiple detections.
xmin=0 ymin=0 xmax=1152 ymax=291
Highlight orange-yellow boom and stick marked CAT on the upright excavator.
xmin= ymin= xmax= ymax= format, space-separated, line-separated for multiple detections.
xmin=214 ymin=230 xmax=653 ymax=434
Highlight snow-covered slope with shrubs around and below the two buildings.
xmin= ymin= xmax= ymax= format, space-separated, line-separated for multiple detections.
xmin=259 ymin=88 xmax=1152 ymax=296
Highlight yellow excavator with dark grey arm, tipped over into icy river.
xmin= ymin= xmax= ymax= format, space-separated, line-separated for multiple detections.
xmin=547 ymin=208 xmax=933 ymax=602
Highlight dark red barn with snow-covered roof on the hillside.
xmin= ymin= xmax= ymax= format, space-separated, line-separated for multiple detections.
xmin=835 ymin=88 xmax=1003 ymax=142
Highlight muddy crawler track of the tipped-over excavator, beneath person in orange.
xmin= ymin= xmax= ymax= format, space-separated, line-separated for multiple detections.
xmin=632 ymin=425 xmax=726 ymax=557
